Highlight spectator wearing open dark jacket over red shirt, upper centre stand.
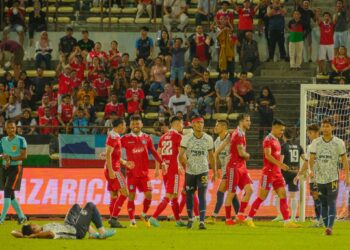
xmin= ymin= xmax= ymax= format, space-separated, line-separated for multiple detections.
xmin=188 ymin=25 xmax=214 ymax=68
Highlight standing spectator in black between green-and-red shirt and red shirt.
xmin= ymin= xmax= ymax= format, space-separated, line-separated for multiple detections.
xmin=296 ymin=0 xmax=316 ymax=62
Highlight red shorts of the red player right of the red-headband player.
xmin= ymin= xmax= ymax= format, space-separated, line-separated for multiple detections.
xmin=226 ymin=168 xmax=253 ymax=193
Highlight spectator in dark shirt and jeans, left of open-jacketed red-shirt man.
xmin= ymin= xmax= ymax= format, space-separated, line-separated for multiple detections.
xmin=170 ymin=38 xmax=189 ymax=87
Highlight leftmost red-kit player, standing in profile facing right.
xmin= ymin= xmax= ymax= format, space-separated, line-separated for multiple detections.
xmin=104 ymin=118 xmax=134 ymax=228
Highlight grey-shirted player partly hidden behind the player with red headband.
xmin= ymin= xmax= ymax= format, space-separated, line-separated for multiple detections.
xmin=205 ymin=120 xmax=239 ymax=224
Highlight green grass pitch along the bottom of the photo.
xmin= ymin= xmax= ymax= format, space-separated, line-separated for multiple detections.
xmin=0 ymin=221 xmax=350 ymax=250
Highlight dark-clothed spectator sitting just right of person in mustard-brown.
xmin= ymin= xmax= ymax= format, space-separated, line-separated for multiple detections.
xmin=240 ymin=31 xmax=260 ymax=72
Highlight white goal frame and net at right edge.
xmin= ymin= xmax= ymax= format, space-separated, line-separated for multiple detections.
xmin=299 ymin=84 xmax=350 ymax=221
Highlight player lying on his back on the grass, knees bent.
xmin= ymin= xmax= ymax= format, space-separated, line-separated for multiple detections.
xmin=11 ymin=202 xmax=115 ymax=239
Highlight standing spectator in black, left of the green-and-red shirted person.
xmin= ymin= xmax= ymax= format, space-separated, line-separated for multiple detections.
xmin=267 ymin=0 xmax=288 ymax=61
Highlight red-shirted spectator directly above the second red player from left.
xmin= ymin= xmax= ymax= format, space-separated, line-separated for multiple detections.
xmin=125 ymin=78 xmax=145 ymax=114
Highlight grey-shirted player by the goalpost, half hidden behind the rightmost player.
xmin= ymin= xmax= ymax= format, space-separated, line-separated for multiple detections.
xmin=294 ymin=124 xmax=323 ymax=227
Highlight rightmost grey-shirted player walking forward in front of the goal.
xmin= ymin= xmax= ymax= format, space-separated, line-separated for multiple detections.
xmin=309 ymin=118 xmax=350 ymax=235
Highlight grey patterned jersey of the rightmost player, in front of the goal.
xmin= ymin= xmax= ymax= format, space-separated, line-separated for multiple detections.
xmin=310 ymin=136 xmax=346 ymax=184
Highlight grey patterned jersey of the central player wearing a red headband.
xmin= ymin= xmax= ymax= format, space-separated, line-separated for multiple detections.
xmin=181 ymin=133 xmax=214 ymax=175
